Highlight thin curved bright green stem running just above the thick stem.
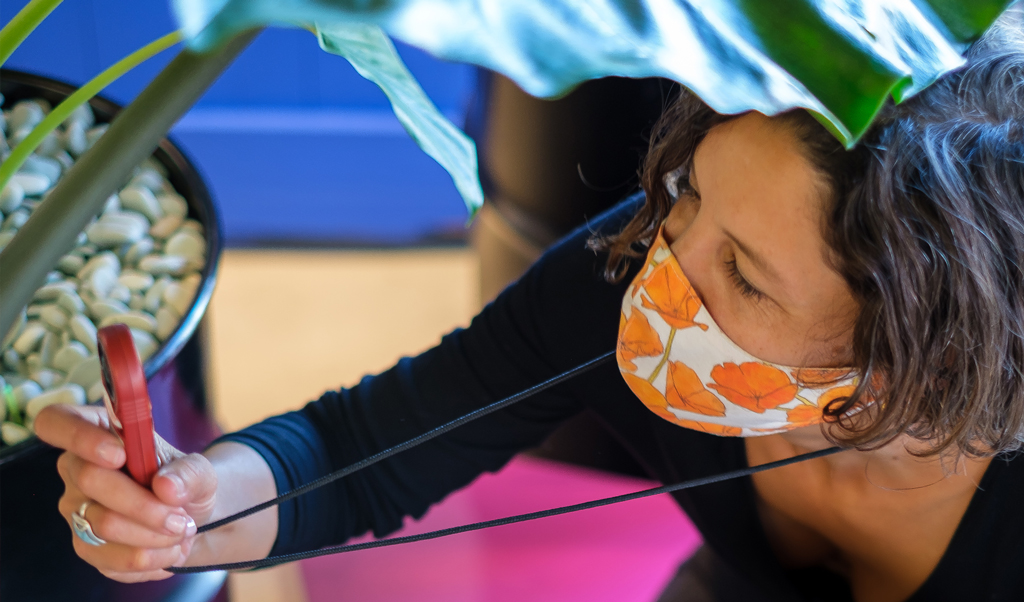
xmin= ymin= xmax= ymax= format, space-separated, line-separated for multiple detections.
xmin=0 ymin=32 xmax=181 ymax=190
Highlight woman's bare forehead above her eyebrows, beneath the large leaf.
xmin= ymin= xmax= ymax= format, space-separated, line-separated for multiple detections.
xmin=692 ymin=113 xmax=839 ymax=298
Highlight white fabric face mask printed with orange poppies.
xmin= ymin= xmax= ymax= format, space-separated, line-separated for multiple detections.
xmin=615 ymin=223 xmax=856 ymax=437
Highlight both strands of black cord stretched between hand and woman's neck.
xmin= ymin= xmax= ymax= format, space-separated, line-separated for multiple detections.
xmin=165 ymin=351 xmax=843 ymax=574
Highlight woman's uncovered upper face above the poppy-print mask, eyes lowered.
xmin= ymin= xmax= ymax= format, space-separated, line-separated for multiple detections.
xmin=665 ymin=113 xmax=858 ymax=368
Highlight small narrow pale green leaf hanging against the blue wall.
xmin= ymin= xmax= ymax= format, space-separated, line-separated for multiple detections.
xmin=316 ymin=23 xmax=483 ymax=215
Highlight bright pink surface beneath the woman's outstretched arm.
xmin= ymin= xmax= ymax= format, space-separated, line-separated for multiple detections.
xmin=300 ymin=458 xmax=700 ymax=602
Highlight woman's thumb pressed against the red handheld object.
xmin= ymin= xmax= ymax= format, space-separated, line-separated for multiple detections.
xmin=152 ymin=454 xmax=217 ymax=524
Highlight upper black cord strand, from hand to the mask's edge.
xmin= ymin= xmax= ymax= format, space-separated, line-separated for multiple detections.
xmin=198 ymin=351 xmax=615 ymax=533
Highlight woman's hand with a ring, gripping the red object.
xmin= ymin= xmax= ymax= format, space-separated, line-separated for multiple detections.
xmin=35 ymin=405 xmax=218 ymax=583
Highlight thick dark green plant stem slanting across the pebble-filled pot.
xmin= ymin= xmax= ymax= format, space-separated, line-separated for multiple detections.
xmin=0 ymin=30 xmax=260 ymax=333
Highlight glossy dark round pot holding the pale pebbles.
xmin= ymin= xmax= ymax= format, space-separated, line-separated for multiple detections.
xmin=0 ymin=70 xmax=226 ymax=602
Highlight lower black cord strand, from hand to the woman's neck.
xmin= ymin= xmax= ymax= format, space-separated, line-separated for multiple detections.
xmin=166 ymin=442 xmax=844 ymax=574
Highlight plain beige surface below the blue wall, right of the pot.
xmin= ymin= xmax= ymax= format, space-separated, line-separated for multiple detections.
xmin=210 ymin=249 xmax=479 ymax=602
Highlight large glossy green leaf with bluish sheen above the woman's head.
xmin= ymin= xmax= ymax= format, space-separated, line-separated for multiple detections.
xmin=172 ymin=0 xmax=1010 ymax=146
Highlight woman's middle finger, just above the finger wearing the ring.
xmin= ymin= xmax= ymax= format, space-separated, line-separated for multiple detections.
xmin=57 ymin=453 xmax=195 ymax=545
